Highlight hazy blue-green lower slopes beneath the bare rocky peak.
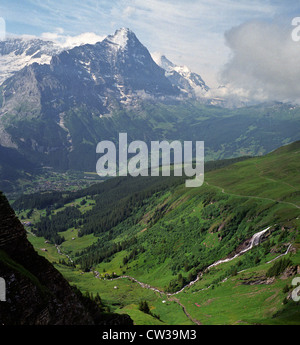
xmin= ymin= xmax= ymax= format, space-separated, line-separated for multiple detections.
xmin=0 ymin=100 xmax=300 ymax=194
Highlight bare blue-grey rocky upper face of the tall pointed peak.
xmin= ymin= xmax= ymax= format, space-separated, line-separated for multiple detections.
xmin=0 ymin=29 xmax=180 ymax=122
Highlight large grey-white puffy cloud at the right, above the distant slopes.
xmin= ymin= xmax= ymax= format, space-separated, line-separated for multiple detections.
xmin=222 ymin=21 xmax=300 ymax=103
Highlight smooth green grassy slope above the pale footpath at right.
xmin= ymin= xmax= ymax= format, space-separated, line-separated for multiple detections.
xmin=207 ymin=142 xmax=300 ymax=208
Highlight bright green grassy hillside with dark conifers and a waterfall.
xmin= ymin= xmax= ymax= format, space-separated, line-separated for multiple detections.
xmin=15 ymin=142 xmax=300 ymax=324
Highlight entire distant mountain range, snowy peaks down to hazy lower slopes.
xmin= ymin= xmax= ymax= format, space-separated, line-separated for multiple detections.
xmin=0 ymin=28 xmax=300 ymax=192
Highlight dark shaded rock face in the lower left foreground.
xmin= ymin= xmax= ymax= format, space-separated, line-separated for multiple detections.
xmin=0 ymin=192 xmax=133 ymax=325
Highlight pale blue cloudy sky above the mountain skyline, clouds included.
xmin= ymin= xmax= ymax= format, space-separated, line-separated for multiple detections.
xmin=0 ymin=0 xmax=300 ymax=99
